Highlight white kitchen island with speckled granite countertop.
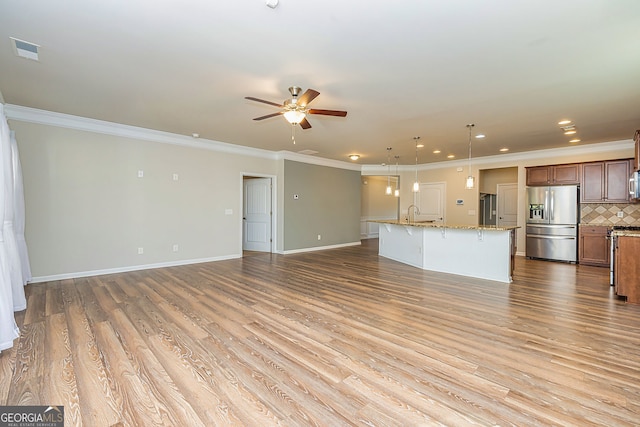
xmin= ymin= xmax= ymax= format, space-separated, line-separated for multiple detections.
xmin=372 ymin=220 xmax=518 ymax=283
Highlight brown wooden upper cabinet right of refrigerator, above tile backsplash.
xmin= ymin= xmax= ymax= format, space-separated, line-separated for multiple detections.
xmin=580 ymin=159 xmax=633 ymax=203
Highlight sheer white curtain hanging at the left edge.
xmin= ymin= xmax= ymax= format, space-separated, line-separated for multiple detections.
xmin=0 ymin=104 xmax=30 ymax=351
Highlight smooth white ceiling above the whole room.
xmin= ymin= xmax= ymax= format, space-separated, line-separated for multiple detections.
xmin=0 ymin=0 xmax=640 ymax=164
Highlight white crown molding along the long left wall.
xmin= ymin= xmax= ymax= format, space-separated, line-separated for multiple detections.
xmin=4 ymin=104 xmax=277 ymax=159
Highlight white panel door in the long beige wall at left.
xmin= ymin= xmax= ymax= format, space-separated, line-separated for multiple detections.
xmin=242 ymin=178 xmax=271 ymax=252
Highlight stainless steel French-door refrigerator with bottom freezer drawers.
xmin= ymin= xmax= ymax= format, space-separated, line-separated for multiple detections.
xmin=526 ymin=185 xmax=580 ymax=262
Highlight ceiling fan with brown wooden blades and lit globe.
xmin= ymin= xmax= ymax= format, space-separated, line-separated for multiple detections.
xmin=245 ymin=86 xmax=347 ymax=129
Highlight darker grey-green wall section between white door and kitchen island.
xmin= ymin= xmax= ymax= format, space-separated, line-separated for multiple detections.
xmin=283 ymin=160 xmax=361 ymax=252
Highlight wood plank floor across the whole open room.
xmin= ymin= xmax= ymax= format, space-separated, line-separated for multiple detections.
xmin=0 ymin=240 xmax=640 ymax=426
